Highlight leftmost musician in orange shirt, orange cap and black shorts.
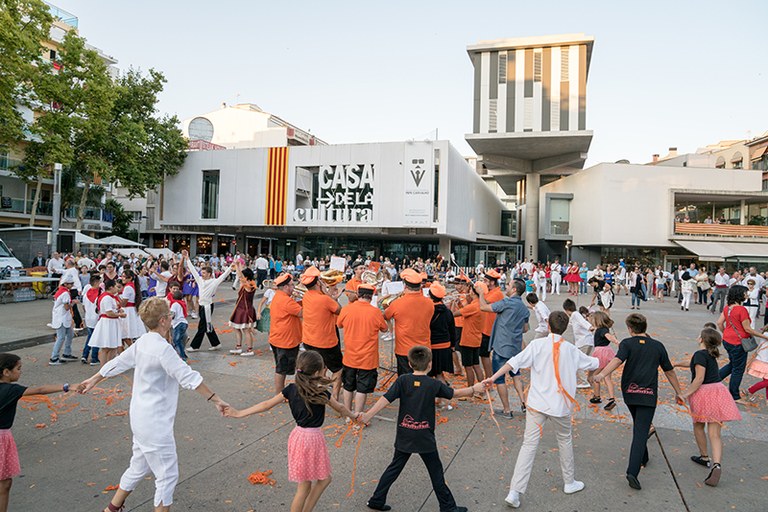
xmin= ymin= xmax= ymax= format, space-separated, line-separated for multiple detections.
xmin=269 ymin=273 xmax=302 ymax=394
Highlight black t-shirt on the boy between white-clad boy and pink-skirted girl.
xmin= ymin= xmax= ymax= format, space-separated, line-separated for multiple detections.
xmin=616 ymin=336 xmax=673 ymax=407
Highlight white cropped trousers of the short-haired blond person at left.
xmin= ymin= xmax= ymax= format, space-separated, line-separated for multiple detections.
xmin=120 ymin=437 xmax=179 ymax=507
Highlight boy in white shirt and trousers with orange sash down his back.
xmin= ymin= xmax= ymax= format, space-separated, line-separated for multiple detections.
xmin=483 ymin=311 xmax=600 ymax=508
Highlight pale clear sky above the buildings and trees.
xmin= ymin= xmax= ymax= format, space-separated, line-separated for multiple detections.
xmin=52 ymin=0 xmax=768 ymax=165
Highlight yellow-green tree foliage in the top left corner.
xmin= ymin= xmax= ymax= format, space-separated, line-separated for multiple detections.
xmin=0 ymin=0 xmax=53 ymax=146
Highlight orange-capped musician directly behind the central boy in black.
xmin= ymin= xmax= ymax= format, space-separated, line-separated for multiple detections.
xmin=384 ymin=268 xmax=435 ymax=375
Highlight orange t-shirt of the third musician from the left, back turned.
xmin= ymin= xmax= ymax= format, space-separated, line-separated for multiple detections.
xmin=336 ymin=300 xmax=387 ymax=370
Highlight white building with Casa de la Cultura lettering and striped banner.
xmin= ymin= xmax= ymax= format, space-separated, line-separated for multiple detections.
xmin=153 ymin=141 xmax=514 ymax=264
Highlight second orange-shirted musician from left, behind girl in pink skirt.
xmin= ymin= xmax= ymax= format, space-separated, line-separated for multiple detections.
xmin=300 ymin=266 xmax=342 ymax=399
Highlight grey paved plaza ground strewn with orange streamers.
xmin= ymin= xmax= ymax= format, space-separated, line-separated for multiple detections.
xmin=0 ymin=287 xmax=768 ymax=512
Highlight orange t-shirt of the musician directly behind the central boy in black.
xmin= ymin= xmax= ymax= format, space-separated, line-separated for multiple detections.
xmin=384 ymin=291 xmax=435 ymax=356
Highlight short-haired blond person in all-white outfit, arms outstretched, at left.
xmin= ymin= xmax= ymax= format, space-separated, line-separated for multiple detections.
xmin=77 ymin=297 xmax=227 ymax=512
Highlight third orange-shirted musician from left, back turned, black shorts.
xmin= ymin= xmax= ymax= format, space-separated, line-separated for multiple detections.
xmin=336 ymin=283 xmax=388 ymax=413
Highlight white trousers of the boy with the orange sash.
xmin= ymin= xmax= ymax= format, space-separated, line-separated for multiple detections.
xmin=509 ymin=408 xmax=576 ymax=494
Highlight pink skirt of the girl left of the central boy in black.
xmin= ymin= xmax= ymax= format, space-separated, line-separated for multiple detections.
xmin=288 ymin=427 xmax=331 ymax=482
